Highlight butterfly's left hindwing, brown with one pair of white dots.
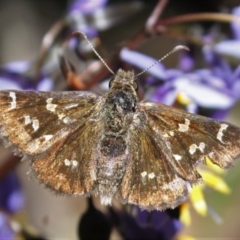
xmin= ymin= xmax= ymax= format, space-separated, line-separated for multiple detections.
xmin=31 ymin=113 xmax=102 ymax=194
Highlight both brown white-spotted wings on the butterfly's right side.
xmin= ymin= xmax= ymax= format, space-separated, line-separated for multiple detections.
xmin=117 ymin=101 xmax=240 ymax=210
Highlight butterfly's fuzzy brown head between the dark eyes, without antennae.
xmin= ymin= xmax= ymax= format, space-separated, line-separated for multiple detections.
xmin=109 ymin=69 xmax=138 ymax=92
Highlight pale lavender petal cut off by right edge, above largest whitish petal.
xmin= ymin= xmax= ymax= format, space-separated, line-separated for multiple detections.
xmin=214 ymin=40 xmax=240 ymax=58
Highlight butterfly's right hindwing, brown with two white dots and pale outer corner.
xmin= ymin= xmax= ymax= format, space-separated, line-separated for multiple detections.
xmin=119 ymin=112 xmax=188 ymax=210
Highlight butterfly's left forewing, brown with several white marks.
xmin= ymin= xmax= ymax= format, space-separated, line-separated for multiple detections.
xmin=0 ymin=90 xmax=101 ymax=155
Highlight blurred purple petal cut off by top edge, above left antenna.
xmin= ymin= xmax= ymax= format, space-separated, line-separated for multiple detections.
xmin=68 ymin=0 xmax=108 ymax=14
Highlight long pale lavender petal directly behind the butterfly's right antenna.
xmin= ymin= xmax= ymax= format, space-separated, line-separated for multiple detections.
xmin=120 ymin=48 xmax=166 ymax=80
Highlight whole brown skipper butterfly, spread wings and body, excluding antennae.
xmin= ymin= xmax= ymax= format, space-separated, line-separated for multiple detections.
xmin=0 ymin=70 xmax=240 ymax=210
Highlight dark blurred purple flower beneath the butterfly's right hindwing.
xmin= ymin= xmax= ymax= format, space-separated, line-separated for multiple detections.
xmin=110 ymin=206 xmax=182 ymax=240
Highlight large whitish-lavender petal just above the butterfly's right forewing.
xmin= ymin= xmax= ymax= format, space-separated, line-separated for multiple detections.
xmin=174 ymin=76 xmax=236 ymax=109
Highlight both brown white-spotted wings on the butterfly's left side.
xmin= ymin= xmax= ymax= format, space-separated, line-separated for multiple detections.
xmin=0 ymin=90 xmax=102 ymax=194
